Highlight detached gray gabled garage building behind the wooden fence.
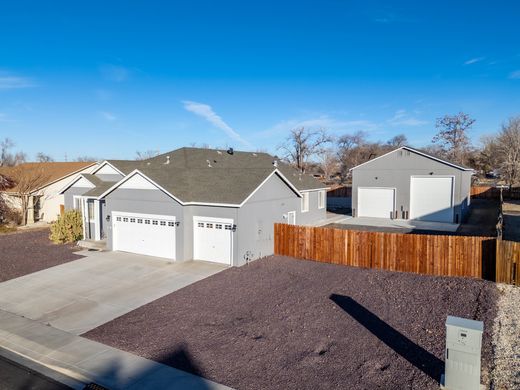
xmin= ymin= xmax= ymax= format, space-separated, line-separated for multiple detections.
xmin=351 ymin=147 xmax=473 ymax=223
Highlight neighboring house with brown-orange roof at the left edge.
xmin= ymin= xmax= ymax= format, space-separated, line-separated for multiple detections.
xmin=0 ymin=162 xmax=97 ymax=223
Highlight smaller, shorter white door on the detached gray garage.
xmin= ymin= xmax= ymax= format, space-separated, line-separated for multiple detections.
xmin=357 ymin=187 xmax=395 ymax=218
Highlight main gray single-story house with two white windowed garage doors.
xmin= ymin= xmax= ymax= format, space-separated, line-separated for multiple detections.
xmin=62 ymin=148 xmax=326 ymax=266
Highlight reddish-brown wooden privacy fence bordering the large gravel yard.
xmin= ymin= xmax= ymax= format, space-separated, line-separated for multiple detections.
xmin=274 ymin=224 xmax=520 ymax=283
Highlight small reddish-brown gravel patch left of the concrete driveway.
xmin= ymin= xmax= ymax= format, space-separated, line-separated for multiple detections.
xmin=0 ymin=229 xmax=83 ymax=282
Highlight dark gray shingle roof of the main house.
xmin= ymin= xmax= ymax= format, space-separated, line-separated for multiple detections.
xmin=104 ymin=148 xmax=326 ymax=204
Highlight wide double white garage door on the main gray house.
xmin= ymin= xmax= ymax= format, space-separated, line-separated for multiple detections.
xmin=112 ymin=212 xmax=175 ymax=260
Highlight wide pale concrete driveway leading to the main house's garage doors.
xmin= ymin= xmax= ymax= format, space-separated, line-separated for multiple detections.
xmin=0 ymin=251 xmax=226 ymax=335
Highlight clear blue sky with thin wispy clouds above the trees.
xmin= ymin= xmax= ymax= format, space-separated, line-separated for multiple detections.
xmin=0 ymin=0 xmax=520 ymax=160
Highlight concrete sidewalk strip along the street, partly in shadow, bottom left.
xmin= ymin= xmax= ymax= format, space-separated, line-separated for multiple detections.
xmin=0 ymin=310 xmax=229 ymax=390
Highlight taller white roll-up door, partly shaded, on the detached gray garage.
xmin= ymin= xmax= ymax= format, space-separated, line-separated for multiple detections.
xmin=410 ymin=176 xmax=453 ymax=222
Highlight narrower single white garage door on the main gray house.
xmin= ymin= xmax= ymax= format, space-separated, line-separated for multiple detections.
xmin=193 ymin=217 xmax=233 ymax=265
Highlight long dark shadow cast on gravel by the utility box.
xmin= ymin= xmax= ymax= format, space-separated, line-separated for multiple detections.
xmin=329 ymin=294 xmax=444 ymax=382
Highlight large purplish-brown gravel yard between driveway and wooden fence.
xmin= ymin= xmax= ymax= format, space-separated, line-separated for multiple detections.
xmin=84 ymin=256 xmax=498 ymax=389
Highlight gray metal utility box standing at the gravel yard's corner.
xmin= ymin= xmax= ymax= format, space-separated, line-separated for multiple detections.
xmin=444 ymin=316 xmax=484 ymax=390
